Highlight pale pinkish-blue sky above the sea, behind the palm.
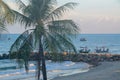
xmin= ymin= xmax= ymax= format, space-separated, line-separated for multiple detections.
xmin=4 ymin=0 xmax=120 ymax=34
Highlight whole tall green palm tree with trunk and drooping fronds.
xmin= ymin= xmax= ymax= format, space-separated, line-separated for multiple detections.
xmin=10 ymin=0 xmax=79 ymax=80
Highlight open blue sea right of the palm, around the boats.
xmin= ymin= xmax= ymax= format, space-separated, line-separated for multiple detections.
xmin=73 ymin=34 xmax=120 ymax=54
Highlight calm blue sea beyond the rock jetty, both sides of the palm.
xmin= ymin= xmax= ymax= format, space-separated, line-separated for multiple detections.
xmin=0 ymin=34 xmax=120 ymax=54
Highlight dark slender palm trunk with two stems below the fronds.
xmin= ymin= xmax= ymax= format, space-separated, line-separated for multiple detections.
xmin=38 ymin=37 xmax=47 ymax=80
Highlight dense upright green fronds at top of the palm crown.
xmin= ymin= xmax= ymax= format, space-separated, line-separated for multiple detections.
xmin=23 ymin=0 xmax=56 ymax=22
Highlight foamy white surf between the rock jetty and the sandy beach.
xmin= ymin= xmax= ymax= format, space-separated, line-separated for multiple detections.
xmin=0 ymin=61 xmax=88 ymax=80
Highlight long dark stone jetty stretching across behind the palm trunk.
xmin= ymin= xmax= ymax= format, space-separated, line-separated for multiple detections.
xmin=0 ymin=53 xmax=120 ymax=66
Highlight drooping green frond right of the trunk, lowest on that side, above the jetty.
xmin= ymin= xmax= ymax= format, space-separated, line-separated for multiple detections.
xmin=43 ymin=32 xmax=76 ymax=53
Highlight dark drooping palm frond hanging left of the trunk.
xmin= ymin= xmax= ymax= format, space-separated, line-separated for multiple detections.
xmin=10 ymin=30 xmax=34 ymax=72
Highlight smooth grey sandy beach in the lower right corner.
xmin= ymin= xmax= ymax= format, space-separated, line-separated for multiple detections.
xmin=52 ymin=61 xmax=120 ymax=80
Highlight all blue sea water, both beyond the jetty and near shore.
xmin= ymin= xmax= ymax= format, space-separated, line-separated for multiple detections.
xmin=0 ymin=34 xmax=120 ymax=80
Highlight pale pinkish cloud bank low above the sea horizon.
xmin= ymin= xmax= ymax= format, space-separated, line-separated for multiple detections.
xmin=78 ymin=17 xmax=120 ymax=34
